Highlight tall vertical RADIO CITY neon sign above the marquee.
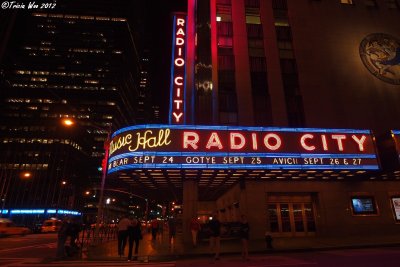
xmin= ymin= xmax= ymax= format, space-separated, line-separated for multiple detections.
xmin=169 ymin=14 xmax=186 ymax=124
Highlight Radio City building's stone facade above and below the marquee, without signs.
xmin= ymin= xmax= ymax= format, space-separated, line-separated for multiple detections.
xmin=187 ymin=0 xmax=400 ymax=242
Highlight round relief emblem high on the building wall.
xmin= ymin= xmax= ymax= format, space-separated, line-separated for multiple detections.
xmin=360 ymin=33 xmax=400 ymax=85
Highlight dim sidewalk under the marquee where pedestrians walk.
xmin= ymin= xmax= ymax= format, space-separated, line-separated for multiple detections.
xmin=87 ymin=233 xmax=400 ymax=262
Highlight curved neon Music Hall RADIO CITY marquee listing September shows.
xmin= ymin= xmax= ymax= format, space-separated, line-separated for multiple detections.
xmin=108 ymin=125 xmax=379 ymax=173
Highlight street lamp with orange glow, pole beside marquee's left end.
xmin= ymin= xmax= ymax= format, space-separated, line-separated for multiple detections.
xmin=62 ymin=118 xmax=111 ymax=243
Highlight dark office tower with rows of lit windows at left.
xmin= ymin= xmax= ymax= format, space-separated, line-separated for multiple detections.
xmin=0 ymin=1 xmax=149 ymax=224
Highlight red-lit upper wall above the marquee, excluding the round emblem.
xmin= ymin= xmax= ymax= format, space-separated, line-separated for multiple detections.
xmin=189 ymin=0 xmax=400 ymax=133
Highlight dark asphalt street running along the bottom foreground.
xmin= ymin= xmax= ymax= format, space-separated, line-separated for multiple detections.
xmin=0 ymin=234 xmax=400 ymax=267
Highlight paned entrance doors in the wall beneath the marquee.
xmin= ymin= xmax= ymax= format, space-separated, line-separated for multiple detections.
xmin=267 ymin=196 xmax=316 ymax=236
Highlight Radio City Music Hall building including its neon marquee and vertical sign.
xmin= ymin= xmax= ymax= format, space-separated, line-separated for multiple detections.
xmin=108 ymin=0 xmax=400 ymax=247
